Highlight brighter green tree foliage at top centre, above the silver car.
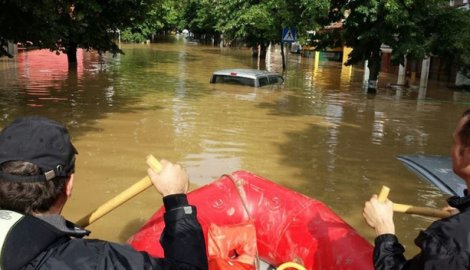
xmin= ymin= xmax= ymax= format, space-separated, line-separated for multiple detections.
xmin=173 ymin=0 xmax=328 ymax=46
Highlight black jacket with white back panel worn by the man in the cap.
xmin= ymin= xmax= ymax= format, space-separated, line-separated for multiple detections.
xmin=0 ymin=195 xmax=207 ymax=270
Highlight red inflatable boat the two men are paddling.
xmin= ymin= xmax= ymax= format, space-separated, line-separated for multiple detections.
xmin=129 ymin=171 xmax=373 ymax=270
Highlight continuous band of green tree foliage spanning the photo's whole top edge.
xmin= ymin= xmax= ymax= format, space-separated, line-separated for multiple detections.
xmin=0 ymin=0 xmax=470 ymax=75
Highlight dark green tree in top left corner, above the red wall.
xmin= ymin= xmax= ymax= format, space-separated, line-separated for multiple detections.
xmin=0 ymin=0 xmax=154 ymax=66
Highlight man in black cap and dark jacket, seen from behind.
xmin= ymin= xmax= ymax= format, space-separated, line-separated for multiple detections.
xmin=0 ymin=117 xmax=207 ymax=270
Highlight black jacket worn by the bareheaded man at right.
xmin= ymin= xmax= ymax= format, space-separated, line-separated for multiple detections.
xmin=374 ymin=196 xmax=470 ymax=270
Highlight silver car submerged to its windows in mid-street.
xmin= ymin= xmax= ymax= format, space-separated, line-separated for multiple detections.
xmin=210 ymin=68 xmax=284 ymax=87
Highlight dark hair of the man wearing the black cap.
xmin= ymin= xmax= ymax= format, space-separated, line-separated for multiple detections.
xmin=0 ymin=161 xmax=68 ymax=214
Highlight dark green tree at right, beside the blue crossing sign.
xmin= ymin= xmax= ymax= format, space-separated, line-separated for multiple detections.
xmin=316 ymin=0 xmax=470 ymax=91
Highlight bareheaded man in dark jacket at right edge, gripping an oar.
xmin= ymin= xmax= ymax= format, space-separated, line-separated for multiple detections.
xmin=363 ymin=110 xmax=470 ymax=270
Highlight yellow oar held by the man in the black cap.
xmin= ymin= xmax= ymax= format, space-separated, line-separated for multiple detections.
xmin=76 ymin=155 xmax=162 ymax=227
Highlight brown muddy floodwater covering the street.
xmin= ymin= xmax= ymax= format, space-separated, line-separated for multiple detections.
xmin=0 ymin=36 xmax=470 ymax=255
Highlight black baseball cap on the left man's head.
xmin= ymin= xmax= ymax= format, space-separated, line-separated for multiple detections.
xmin=0 ymin=116 xmax=78 ymax=182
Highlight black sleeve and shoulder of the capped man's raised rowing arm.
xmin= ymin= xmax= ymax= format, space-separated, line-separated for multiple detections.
xmin=23 ymin=194 xmax=208 ymax=270
